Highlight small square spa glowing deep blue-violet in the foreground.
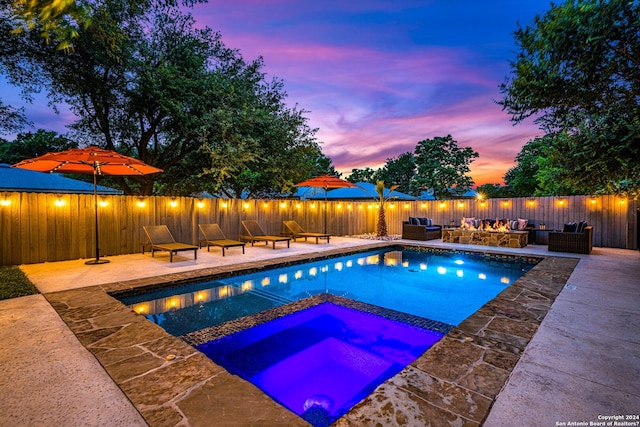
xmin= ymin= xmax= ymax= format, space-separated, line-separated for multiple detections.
xmin=197 ymin=303 xmax=443 ymax=427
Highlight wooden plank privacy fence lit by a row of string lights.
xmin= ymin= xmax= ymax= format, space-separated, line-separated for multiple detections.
xmin=0 ymin=193 xmax=640 ymax=265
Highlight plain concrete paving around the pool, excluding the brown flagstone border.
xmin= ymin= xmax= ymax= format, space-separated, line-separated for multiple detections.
xmin=0 ymin=238 xmax=640 ymax=427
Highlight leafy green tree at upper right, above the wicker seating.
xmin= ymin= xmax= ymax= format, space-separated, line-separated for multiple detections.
xmin=500 ymin=0 xmax=640 ymax=197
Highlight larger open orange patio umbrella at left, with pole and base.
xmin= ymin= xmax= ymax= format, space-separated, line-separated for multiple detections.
xmin=13 ymin=146 xmax=162 ymax=265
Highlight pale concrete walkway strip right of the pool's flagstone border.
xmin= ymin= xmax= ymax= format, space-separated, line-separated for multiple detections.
xmin=484 ymin=248 xmax=640 ymax=427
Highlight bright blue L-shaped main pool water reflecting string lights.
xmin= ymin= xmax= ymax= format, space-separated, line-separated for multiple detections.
xmin=121 ymin=244 xmax=535 ymax=336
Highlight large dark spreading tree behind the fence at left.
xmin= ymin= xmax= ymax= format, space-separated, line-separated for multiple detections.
xmin=0 ymin=0 xmax=326 ymax=195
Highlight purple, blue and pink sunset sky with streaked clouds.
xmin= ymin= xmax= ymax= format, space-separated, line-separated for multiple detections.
xmin=0 ymin=0 xmax=550 ymax=185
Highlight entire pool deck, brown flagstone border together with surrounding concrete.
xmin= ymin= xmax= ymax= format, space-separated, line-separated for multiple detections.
xmin=0 ymin=238 xmax=640 ymax=426
